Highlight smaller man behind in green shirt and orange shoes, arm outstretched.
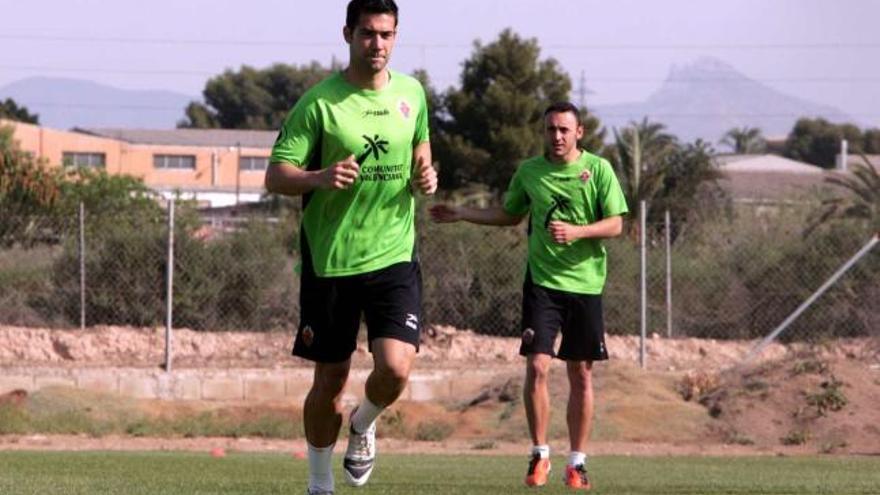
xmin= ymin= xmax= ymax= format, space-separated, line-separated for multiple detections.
xmin=431 ymin=103 xmax=628 ymax=490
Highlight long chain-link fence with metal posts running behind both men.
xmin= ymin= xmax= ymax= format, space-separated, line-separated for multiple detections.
xmin=0 ymin=200 xmax=880 ymax=341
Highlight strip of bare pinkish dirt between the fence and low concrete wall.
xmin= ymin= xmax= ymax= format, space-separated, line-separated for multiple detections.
xmin=0 ymin=326 xmax=796 ymax=371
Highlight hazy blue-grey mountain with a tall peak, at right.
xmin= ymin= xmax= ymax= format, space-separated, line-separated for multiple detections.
xmin=593 ymin=57 xmax=853 ymax=145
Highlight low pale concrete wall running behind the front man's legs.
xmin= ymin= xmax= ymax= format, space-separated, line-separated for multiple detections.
xmin=0 ymin=368 xmax=518 ymax=402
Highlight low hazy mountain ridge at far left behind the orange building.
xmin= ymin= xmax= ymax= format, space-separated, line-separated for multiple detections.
xmin=0 ymin=77 xmax=198 ymax=129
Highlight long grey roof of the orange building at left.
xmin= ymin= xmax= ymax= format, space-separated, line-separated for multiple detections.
xmin=74 ymin=128 xmax=278 ymax=149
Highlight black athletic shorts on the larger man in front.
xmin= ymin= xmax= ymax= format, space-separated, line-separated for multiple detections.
xmin=293 ymin=261 xmax=422 ymax=363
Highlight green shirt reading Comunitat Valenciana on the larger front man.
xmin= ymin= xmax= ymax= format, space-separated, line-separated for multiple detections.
xmin=271 ymin=71 xmax=428 ymax=277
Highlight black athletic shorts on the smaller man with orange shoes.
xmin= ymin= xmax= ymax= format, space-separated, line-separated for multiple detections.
xmin=519 ymin=273 xmax=608 ymax=361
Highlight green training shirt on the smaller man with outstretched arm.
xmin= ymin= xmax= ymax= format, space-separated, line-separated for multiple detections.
xmin=504 ymin=151 xmax=629 ymax=294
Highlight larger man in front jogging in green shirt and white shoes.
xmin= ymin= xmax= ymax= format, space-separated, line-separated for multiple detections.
xmin=266 ymin=0 xmax=437 ymax=495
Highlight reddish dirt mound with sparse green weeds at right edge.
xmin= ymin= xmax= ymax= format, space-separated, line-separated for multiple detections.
xmin=698 ymin=351 xmax=880 ymax=455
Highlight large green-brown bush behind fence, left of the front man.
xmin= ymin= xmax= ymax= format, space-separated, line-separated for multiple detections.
xmin=48 ymin=209 xmax=295 ymax=330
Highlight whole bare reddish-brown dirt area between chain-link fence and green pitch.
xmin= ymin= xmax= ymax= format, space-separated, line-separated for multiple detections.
xmin=0 ymin=327 xmax=880 ymax=455
